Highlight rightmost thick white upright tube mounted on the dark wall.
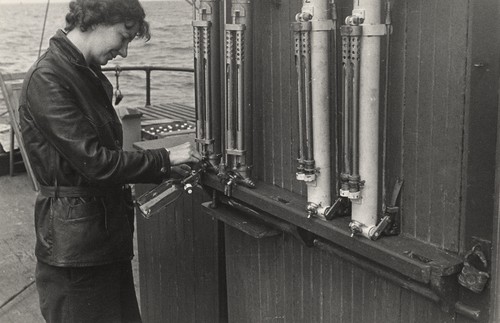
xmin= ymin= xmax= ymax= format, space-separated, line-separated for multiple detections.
xmin=352 ymin=0 xmax=385 ymax=233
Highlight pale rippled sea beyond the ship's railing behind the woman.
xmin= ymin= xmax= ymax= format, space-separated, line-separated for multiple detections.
xmin=0 ymin=0 xmax=194 ymax=110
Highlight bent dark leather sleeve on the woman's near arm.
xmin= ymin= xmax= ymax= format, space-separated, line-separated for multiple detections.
xmin=27 ymin=68 xmax=170 ymax=185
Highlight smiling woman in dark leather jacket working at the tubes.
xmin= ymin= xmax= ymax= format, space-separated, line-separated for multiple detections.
xmin=19 ymin=0 xmax=201 ymax=323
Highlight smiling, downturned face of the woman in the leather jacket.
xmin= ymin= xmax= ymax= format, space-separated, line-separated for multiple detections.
xmin=86 ymin=22 xmax=138 ymax=65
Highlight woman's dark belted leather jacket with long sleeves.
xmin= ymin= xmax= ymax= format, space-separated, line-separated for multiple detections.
xmin=19 ymin=31 xmax=170 ymax=266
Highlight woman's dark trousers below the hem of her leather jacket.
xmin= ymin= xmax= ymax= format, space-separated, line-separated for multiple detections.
xmin=36 ymin=261 xmax=142 ymax=323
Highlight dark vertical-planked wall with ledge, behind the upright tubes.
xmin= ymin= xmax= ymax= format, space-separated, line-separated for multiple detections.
xmin=137 ymin=0 xmax=500 ymax=323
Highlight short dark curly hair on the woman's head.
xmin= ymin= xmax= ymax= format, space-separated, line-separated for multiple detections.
xmin=64 ymin=0 xmax=151 ymax=41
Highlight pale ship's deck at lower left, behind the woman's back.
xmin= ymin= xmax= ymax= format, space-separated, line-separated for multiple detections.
xmin=0 ymin=173 xmax=43 ymax=323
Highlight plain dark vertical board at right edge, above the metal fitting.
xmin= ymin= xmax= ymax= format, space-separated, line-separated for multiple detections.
xmin=464 ymin=0 xmax=500 ymax=249
